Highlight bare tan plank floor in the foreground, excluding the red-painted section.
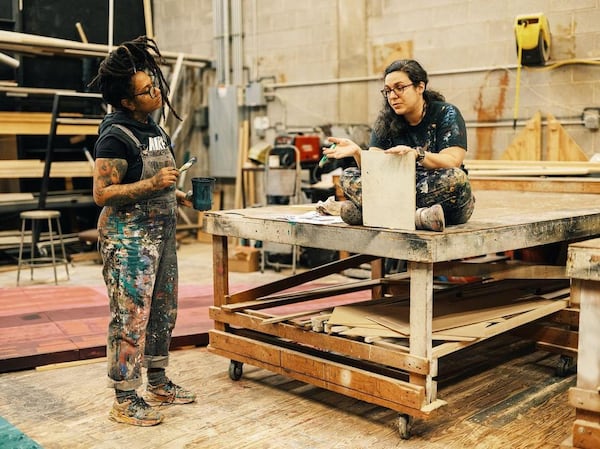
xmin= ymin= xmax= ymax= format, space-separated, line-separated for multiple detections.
xmin=0 ymin=336 xmax=575 ymax=449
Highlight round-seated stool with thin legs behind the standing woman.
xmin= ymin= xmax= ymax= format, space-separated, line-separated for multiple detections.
xmin=17 ymin=210 xmax=69 ymax=285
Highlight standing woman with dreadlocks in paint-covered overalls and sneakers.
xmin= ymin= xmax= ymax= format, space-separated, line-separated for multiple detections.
xmin=90 ymin=36 xmax=196 ymax=426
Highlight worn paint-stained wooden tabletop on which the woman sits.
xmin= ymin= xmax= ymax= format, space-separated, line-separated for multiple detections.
xmin=205 ymin=191 xmax=600 ymax=262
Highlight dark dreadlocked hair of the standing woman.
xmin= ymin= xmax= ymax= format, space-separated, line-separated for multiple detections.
xmin=88 ymin=36 xmax=181 ymax=120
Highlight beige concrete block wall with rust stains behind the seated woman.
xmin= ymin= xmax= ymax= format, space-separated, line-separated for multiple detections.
xmin=154 ymin=0 xmax=600 ymax=159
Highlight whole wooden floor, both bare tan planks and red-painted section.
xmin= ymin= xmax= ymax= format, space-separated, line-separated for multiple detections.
xmin=0 ymin=247 xmax=575 ymax=449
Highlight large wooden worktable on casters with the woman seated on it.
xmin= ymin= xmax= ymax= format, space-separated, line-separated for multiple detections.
xmin=204 ymin=191 xmax=600 ymax=433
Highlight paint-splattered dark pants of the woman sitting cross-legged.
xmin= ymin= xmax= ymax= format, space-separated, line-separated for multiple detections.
xmin=340 ymin=167 xmax=475 ymax=225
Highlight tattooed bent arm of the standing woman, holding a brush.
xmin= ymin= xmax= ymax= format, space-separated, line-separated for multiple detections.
xmin=94 ymin=158 xmax=179 ymax=207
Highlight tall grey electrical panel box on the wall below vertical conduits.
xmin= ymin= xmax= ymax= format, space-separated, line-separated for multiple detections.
xmin=208 ymin=85 xmax=241 ymax=178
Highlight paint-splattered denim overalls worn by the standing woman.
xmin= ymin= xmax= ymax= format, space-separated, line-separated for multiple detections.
xmin=98 ymin=129 xmax=178 ymax=390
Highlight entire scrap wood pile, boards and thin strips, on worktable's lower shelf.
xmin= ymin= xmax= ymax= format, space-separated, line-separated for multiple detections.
xmin=263 ymin=264 xmax=569 ymax=344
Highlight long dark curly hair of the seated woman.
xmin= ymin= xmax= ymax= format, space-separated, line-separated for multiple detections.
xmin=373 ymin=59 xmax=445 ymax=142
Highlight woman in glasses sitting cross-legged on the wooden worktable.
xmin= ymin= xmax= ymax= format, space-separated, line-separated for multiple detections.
xmin=323 ymin=59 xmax=475 ymax=231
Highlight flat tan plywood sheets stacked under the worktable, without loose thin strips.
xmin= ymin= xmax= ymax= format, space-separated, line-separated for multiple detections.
xmin=323 ymin=274 xmax=569 ymax=341
